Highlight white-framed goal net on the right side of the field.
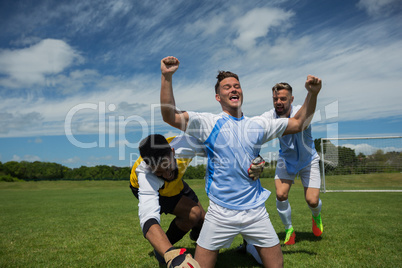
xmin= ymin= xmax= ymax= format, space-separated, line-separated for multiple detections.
xmin=316 ymin=137 xmax=402 ymax=192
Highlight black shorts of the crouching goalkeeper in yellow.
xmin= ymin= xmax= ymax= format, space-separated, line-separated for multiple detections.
xmin=130 ymin=181 xmax=198 ymax=214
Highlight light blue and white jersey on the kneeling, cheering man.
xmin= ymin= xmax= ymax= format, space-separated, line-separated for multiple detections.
xmin=186 ymin=112 xmax=288 ymax=210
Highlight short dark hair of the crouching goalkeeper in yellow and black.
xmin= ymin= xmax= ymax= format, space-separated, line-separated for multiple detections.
xmin=138 ymin=134 xmax=172 ymax=166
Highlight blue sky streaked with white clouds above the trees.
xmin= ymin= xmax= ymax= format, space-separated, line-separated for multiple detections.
xmin=0 ymin=0 xmax=402 ymax=167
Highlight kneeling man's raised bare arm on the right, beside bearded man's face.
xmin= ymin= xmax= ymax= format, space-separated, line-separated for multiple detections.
xmin=283 ymin=75 xmax=322 ymax=135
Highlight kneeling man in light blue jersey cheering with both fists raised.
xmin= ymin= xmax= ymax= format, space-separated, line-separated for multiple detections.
xmin=160 ymin=56 xmax=321 ymax=268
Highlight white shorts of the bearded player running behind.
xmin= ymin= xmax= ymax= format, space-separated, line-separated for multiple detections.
xmin=275 ymin=157 xmax=321 ymax=188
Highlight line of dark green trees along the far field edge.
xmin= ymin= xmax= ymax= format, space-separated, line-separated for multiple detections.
xmin=0 ymin=139 xmax=402 ymax=181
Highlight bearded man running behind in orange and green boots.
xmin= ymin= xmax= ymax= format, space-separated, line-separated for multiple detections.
xmin=263 ymin=82 xmax=323 ymax=245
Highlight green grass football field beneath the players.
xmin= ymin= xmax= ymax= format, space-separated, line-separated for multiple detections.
xmin=0 ymin=179 xmax=402 ymax=267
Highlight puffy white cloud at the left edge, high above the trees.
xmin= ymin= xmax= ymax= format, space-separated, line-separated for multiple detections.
xmin=0 ymin=39 xmax=82 ymax=87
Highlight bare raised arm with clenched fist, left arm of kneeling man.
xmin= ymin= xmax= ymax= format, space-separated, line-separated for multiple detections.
xmin=161 ymin=56 xmax=189 ymax=131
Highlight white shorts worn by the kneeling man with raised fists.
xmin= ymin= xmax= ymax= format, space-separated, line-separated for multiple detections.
xmin=197 ymin=201 xmax=279 ymax=250
